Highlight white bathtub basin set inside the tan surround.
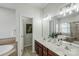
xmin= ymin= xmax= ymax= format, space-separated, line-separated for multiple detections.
xmin=0 ymin=45 xmax=14 ymax=56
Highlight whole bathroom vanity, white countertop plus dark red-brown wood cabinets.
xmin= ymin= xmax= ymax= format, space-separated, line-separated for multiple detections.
xmin=35 ymin=39 xmax=79 ymax=56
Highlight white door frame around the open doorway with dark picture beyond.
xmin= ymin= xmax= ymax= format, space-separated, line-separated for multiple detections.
xmin=17 ymin=16 xmax=34 ymax=56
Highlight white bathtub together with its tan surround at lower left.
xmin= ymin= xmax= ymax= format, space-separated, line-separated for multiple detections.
xmin=0 ymin=37 xmax=17 ymax=56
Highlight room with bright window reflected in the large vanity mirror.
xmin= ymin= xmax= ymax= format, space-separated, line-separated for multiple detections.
xmin=49 ymin=19 xmax=79 ymax=42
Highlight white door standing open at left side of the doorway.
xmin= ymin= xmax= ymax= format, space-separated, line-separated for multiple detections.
xmin=19 ymin=16 xmax=24 ymax=55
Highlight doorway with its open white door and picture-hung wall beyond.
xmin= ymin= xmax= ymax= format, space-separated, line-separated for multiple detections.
xmin=18 ymin=16 xmax=33 ymax=55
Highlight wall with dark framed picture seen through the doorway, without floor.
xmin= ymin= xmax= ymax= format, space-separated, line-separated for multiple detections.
xmin=23 ymin=17 xmax=32 ymax=47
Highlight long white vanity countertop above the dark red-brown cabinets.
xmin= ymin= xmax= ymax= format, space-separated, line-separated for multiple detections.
xmin=35 ymin=39 xmax=79 ymax=56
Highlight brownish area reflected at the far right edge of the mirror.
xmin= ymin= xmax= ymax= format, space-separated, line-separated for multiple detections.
xmin=70 ymin=22 xmax=79 ymax=41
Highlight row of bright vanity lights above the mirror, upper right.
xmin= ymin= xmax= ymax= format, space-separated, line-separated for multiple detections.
xmin=59 ymin=3 xmax=79 ymax=16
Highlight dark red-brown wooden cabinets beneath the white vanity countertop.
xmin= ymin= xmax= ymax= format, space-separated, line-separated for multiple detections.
xmin=35 ymin=40 xmax=58 ymax=56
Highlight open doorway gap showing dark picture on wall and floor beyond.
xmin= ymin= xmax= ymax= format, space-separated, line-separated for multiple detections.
xmin=23 ymin=17 xmax=33 ymax=56
